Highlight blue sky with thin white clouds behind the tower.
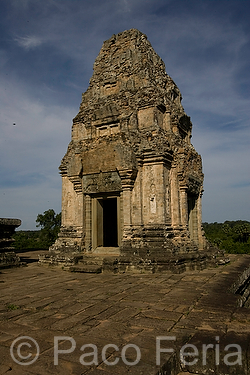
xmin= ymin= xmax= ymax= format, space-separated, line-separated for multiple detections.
xmin=0 ymin=0 xmax=250 ymax=229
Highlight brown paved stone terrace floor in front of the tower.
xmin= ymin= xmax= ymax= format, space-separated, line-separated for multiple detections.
xmin=0 ymin=252 xmax=250 ymax=375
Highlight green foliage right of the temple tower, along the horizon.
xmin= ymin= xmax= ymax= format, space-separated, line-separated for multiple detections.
xmin=203 ymin=220 xmax=250 ymax=254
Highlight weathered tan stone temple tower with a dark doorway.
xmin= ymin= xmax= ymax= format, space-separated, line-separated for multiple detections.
xmin=47 ymin=29 xmax=209 ymax=270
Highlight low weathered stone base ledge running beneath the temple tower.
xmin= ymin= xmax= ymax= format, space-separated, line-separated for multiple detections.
xmin=39 ymin=251 xmax=229 ymax=273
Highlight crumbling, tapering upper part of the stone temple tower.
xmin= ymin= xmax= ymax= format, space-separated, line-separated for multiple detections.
xmin=74 ymin=29 xmax=191 ymax=144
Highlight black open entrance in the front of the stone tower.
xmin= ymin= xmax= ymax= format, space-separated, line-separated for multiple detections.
xmin=102 ymin=198 xmax=118 ymax=247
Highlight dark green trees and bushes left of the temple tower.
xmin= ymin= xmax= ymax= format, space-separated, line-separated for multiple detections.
xmin=14 ymin=209 xmax=61 ymax=250
